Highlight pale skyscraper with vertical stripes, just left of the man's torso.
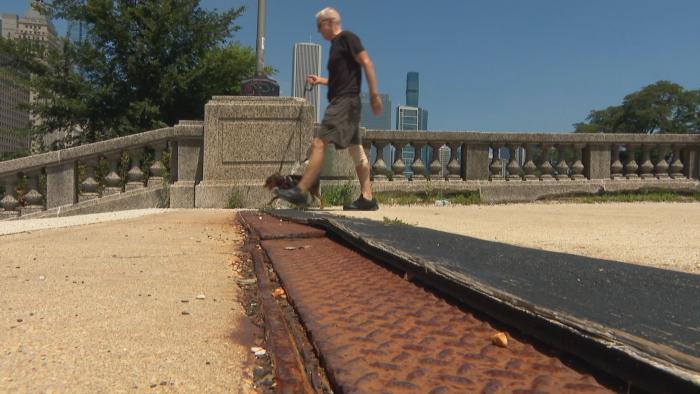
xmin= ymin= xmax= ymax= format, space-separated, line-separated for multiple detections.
xmin=292 ymin=42 xmax=321 ymax=123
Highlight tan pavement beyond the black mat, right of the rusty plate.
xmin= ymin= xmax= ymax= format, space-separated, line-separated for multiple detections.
xmin=328 ymin=202 xmax=700 ymax=274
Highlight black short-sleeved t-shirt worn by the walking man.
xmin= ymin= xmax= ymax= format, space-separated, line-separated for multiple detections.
xmin=328 ymin=30 xmax=365 ymax=101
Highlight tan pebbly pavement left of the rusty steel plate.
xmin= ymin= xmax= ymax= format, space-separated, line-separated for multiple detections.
xmin=0 ymin=210 xmax=255 ymax=393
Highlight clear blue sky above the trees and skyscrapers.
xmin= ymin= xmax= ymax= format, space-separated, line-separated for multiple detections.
xmin=5 ymin=0 xmax=700 ymax=132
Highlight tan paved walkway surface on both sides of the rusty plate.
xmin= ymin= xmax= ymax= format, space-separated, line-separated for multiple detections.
xmin=0 ymin=203 xmax=700 ymax=392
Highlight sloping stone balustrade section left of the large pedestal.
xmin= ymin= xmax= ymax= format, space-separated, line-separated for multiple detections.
xmin=0 ymin=121 xmax=203 ymax=219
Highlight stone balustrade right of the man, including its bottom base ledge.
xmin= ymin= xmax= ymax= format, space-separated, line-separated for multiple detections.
xmin=364 ymin=130 xmax=700 ymax=202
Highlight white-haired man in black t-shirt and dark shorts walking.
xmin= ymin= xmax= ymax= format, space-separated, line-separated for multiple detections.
xmin=277 ymin=7 xmax=382 ymax=211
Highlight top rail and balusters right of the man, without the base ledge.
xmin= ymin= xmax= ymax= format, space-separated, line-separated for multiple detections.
xmin=365 ymin=130 xmax=700 ymax=181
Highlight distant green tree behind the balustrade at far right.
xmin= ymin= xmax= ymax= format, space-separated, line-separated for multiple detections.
xmin=574 ymin=81 xmax=700 ymax=134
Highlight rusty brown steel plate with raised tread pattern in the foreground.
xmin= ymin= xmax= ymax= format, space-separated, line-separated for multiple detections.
xmin=261 ymin=238 xmax=610 ymax=393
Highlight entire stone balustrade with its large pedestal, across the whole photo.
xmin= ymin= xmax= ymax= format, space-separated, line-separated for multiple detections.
xmin=0 ymin=96 xmax=700 ymax=219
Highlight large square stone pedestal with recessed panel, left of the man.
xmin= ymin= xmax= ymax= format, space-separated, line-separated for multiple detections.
xmin=191 ymin=96 xmax=313 ymax=208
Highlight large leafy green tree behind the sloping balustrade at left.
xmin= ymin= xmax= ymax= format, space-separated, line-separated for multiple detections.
xmin=0 ymin=0 xmax=270 ymax=148
